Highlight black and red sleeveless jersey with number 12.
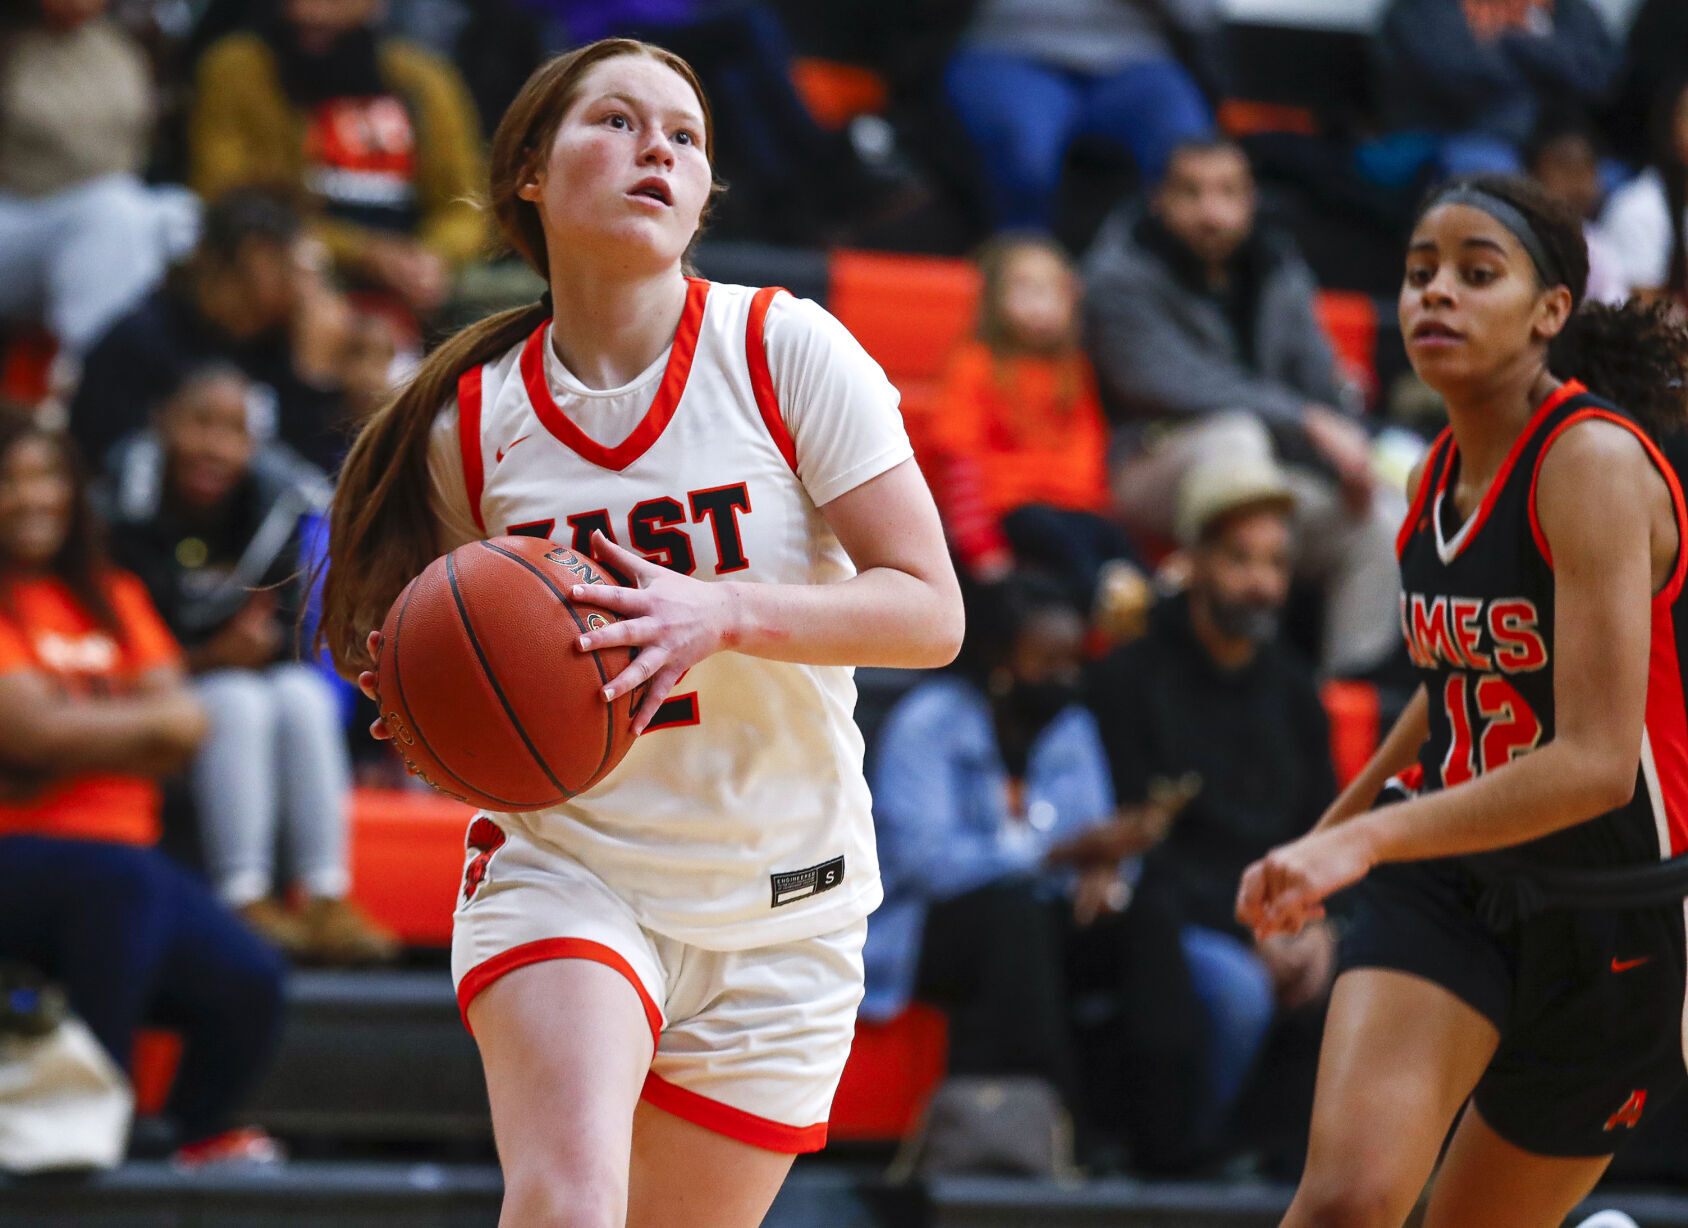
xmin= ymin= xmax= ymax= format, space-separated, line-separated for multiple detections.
xmin=1396 ymin=380 xmax=1688 ymax=867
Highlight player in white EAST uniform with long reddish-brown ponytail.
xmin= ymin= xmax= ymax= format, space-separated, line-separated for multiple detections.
xmin=322 ymin=41 xmax=962 ymax=1228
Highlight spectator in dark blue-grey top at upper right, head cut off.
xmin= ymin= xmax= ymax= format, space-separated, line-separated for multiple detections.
xmin=1362 ymin=0 xmax=1619 ymax=179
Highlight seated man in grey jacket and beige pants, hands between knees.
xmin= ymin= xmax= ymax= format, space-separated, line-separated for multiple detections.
xmin=1084 ymin=140 xmax=1406 ymax=674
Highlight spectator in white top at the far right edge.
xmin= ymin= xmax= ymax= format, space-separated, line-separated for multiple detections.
xmin=1600 ymin=76 xmax=1688 ymax=302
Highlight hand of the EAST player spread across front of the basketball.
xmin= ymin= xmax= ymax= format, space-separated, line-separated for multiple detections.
xmin=569 ymin=532 xmax=731 ymax=733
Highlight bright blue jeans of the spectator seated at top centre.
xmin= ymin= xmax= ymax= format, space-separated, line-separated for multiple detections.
xmin=944 ymin=51 xmax=1214 ymax=228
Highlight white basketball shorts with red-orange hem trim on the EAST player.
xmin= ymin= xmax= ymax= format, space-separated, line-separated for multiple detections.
xmin=451 ymin=814 xmax=868 ymax=1154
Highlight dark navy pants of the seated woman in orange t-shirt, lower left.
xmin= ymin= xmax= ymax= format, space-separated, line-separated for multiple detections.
xmin=0 ymin=836 xmax=284 ymax=1142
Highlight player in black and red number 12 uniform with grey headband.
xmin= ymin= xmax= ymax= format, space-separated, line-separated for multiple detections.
xmin=1237 ymin=177 xmax=1688 ymax=1228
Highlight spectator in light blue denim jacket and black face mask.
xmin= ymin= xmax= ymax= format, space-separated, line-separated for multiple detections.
xmin=861 ymin=574 xmax=1190 ymax=1168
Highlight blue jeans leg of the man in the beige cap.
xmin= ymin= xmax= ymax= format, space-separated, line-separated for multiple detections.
xmin=1178 ymin=926 xmax=1278 ymax=1137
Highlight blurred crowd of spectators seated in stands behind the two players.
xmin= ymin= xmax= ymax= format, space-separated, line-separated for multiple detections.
xmin=0 ymin=0 xmax=1688 ymax=1174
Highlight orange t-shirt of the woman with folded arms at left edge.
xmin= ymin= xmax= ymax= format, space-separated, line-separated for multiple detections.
xmin=0 ymin=573 xmax=181 ymax=845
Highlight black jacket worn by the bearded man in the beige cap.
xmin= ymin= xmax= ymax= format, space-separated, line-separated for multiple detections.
xmin=1090 ymin=595 xmax=1337 ymax=934
